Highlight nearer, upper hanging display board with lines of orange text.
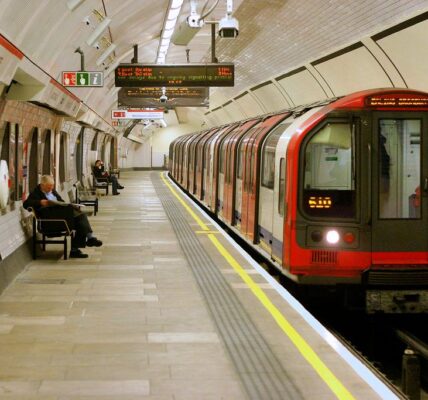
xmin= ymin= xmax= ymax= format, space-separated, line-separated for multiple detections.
xmin=115 ymin=63 xmax=235 ymax=87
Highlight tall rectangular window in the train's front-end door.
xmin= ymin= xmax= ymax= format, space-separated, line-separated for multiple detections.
xmin=378 ymin=119 xmax=422 ymax=219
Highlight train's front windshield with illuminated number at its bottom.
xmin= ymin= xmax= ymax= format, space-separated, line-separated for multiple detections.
xmin=303 ymin=122 xmax=356 ymax=218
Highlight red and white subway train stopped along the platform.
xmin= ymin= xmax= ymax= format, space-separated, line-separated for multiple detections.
xmin=169 ymin=88 xmax=428 ymax=313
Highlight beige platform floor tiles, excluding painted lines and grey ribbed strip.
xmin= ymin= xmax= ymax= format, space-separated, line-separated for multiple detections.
xmin=0 ymin=172 xmax=394 ymax=400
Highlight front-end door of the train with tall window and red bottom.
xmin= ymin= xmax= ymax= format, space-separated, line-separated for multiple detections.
xmin=371 ymin=112 xmax=428 ymax=265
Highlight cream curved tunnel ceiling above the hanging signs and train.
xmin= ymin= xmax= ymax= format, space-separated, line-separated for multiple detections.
xmin=0 ymin=0 xmax=428 ymax=128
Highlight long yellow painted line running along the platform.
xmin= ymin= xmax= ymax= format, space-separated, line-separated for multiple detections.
xmin=162 ymin=175 xmax=355 ymax=400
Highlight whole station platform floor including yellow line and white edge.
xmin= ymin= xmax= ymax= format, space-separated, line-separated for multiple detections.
xmin=0 ymin=172 xmax=396 ymax=400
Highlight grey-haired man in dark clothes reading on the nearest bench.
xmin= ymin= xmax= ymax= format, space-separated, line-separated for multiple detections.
xmin=23 ymin=175 xmax=103 ymax=258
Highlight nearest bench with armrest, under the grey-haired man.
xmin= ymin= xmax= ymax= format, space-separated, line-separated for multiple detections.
xmin=28 ymin=207 xmax=73 ymax=260
